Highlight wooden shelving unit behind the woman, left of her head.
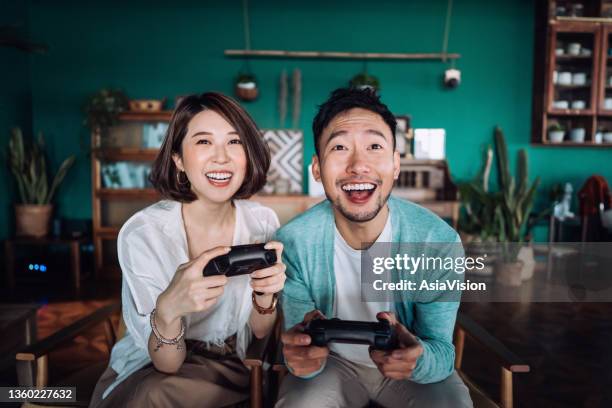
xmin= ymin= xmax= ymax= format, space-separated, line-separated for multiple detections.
xmin=91 ymin=111 xmax=172 ymax=278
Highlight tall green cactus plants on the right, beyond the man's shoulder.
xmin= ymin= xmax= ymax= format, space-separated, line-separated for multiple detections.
xmin=459 ymin=127 xmax=540 ymax=260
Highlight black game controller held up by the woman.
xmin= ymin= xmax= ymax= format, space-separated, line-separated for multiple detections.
xmin=202 ymin=244 xmax=276 ymax=277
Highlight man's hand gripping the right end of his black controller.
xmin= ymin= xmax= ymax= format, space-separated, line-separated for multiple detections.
xmin=370 ymin=312 xmax=423 ymax=380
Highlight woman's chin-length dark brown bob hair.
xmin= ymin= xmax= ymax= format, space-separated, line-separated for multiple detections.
xmin=149 ymin=92 xmax=270 ymax=203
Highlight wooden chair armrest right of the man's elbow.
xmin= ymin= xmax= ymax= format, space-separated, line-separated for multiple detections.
xmin=457 ymin=312 xmax=530 ymax=373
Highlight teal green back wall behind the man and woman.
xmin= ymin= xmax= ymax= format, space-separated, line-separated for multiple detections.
xmin=2 ymin=0 xmax=612 ymax=241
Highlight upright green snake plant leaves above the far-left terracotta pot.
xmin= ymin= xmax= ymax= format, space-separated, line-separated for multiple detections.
xmin=8 ymin=128 xmax=75 ymax=205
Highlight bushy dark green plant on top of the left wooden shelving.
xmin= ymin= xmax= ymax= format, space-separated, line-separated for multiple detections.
xmin=83 ymin=89 xmax=129 ymax=131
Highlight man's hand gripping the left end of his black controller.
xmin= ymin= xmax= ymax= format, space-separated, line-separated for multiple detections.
xmin=281 ymin=310 xmax=329 ymax=377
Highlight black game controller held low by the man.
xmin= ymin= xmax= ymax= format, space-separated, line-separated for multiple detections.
xmin=304 ymin=319 xmax=397 ymax=350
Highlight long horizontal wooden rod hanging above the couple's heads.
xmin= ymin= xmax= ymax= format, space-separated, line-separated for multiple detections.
xmin=224 ymin=50 xmax=461 ymax=61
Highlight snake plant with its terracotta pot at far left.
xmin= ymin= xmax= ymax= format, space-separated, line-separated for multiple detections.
xmin=9 ymin=128 xmax=75 ymax=238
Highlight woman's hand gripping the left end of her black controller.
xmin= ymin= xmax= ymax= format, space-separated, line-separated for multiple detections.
xmin=155 ymin=246 xmax=230 ymax=328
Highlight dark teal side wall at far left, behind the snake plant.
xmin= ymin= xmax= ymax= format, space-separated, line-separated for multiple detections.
xmin=0 ymin=1 xmax=32 ymax=239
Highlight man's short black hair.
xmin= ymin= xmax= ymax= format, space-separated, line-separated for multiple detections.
xmin=312 ymin=88 xmax=397 ymax=156
